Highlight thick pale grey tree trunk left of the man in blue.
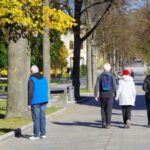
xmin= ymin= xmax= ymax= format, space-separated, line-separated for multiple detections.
xmin=6 ymin=38 xmax=30 ymax=117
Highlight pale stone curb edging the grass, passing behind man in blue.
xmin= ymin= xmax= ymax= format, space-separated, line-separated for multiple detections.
xmin=0 ymin=106 xmax=68 ymax=142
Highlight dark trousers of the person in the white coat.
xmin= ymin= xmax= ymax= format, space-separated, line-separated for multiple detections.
xmin=122 ymin=105 xmax=132 ymax=124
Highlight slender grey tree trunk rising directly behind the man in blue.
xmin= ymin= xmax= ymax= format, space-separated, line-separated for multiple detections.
xmin=43 ymin=0 xmax=50 ymax=104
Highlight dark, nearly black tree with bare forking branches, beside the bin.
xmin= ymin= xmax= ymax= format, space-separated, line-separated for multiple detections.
xmin=70 ymin=0 xmax=112 ymax=100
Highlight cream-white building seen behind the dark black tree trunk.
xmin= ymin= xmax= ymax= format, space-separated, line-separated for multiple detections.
xmin=61 ymin=30 xmax=87 ymax=68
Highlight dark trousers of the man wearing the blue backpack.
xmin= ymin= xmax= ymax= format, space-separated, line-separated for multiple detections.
xmin=100 ymin=98 xmax=113 ymax=125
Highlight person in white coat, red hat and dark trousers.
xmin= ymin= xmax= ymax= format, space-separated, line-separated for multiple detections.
xmin=115 ymin=69 xmax=136 ymax=128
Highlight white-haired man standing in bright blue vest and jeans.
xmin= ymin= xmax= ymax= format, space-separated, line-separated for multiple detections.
xmin=28 ymin=65 xmax=48 ymax=140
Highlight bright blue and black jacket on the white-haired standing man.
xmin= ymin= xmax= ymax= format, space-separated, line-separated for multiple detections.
xmin=28 ymin=73 xmax=48 ymax=105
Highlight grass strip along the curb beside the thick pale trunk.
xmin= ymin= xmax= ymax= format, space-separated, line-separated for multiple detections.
xmin=0 ymin=100 xmax=60 ymax=135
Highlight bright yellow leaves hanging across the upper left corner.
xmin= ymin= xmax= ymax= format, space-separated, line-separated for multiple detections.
xmin=0 ymin=0 xmax=76 ymax=32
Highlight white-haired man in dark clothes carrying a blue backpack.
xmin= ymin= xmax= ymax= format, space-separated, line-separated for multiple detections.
xmin=94 ymin=63 xmax=117 ymax=128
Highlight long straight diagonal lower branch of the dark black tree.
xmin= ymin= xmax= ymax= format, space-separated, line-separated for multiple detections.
xmin=81 ymin=3 xmax=112 ymax=42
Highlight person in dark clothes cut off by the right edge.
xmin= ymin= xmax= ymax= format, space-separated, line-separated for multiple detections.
xmin=143 ymin=70 xmax=150 ymax=127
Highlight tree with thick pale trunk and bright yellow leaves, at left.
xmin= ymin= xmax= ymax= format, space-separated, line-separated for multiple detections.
xmin=0 ymin=0 xmax=75 ymax=117
